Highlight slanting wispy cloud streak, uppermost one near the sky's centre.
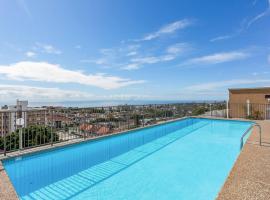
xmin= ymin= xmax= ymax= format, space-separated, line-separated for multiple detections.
xmin=139 ymin=19 xmax=193 ymax=41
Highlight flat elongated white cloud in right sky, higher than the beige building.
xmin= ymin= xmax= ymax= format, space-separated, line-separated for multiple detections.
xmin=182 ymin=51 xmax=249 ymax=65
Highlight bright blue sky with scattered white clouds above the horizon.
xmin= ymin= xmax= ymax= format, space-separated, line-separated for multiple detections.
xmin=0 ymin=0 xmax=270 ymax=102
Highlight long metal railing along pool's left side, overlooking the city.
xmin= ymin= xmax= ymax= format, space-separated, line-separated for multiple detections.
xmin=0 ymin=102 xmax=224 ymax=155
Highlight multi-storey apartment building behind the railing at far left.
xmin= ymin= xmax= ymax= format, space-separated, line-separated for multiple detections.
xmin=0 ymin=100 xmax=47 ymax=135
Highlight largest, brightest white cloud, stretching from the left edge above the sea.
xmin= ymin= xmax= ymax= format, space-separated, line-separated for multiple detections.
xmin=0 ymin=61 xmax=144 ymax=89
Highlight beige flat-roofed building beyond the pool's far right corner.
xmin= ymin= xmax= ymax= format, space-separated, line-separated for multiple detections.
xmin=229 ymin=87 xmax=270 ymax=119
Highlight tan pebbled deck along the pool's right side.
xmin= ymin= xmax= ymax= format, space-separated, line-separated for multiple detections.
xmin=216 ymin=120 xmax=270 ymax=200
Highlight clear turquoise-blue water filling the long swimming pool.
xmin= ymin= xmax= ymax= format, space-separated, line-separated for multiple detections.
xmin=3 ymin=118 xmax=251 ymax=200
